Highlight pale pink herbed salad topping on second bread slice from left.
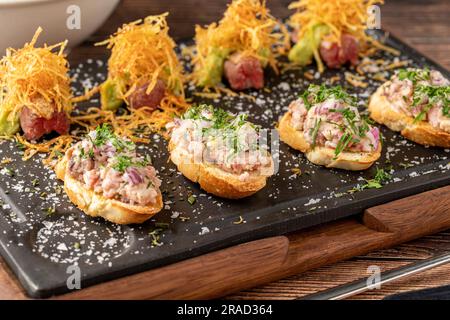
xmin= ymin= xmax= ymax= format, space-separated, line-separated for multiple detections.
xmin=167 ymin=105 xmax=273 ymax=181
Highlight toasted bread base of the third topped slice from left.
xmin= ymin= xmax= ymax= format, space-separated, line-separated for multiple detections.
xmin=278 ymin=112 xmax=381 ymax=171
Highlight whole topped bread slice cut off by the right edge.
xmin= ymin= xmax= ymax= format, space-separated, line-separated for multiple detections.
xmin=369 ymin=69 xmax=450 ymax=148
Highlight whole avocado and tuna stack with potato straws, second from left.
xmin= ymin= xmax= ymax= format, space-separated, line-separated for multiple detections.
xmin=97 ymin=13 xmax=186 ymax=125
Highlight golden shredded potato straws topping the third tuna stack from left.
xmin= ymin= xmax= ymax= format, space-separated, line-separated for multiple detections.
xmin=192 ymin=0 xmax=290 ymax=90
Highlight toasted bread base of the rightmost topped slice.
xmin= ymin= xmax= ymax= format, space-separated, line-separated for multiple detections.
xmin=369 ymin=86 xmax=450 ymax=148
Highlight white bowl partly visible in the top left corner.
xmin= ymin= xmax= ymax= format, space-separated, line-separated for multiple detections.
xmin=0 ymin=0 xmax=119 ymax=54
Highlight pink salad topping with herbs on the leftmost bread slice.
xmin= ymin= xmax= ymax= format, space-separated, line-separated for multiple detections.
xmin=68 ymin=125 xmax=161 ymax=206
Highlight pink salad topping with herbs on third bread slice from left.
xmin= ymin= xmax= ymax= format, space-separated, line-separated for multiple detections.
xmin=288 ymin=85 xmax=380 ymax=157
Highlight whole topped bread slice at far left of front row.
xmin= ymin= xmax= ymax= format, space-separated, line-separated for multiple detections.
xmin=56 ymin=125 xmax=163 ymax=224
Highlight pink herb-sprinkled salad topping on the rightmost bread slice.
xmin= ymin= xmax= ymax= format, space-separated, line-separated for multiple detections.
xmin=383 ymin=69 xmax=450 ymax=133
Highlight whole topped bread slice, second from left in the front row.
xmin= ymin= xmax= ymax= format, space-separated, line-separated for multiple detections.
xmin=167 ymin=105 xmax=274 ymax=199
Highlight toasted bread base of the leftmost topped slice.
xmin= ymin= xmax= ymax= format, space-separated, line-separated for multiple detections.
xmin=55 ymin=149 xmax=163 ymax=224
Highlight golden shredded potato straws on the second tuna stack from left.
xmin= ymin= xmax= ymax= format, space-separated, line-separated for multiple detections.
xmin=90 ymin=13 xmax=189 ymax=134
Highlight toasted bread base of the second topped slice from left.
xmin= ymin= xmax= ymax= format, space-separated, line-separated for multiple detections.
xmin=169 ymin=143 xmax=273 ymax=199
